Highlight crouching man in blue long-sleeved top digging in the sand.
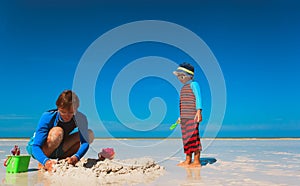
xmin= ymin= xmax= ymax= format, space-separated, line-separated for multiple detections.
xmin=26 ymin=90 xmax=94 ymax=171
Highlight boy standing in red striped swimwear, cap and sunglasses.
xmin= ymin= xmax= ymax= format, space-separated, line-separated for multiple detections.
xmin=173 ymin=63 xmax=202 ymax=167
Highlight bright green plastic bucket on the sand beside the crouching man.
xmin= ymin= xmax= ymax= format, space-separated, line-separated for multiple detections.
xmin=6 ymin=155 xmax=30 ymax=173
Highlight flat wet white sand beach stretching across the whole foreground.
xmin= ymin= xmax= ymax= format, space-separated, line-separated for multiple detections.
xmin=0 ymin=139 xmax=300 ymax=186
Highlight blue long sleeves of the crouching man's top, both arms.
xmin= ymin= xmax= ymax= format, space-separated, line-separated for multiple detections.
xmin=32 ymin=110 xmax=89 ymax=165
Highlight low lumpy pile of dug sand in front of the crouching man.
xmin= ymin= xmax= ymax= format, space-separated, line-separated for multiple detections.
xmin=45 ymin=157 xmax=164 ymax=185
